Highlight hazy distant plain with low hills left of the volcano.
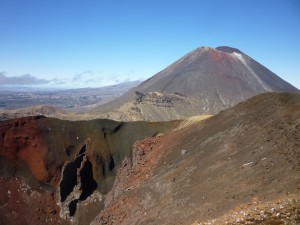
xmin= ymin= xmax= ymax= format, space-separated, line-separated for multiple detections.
xmin=0 ymin=81 xmax=140 ymax=120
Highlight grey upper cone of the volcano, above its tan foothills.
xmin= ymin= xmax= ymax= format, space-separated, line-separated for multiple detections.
xmin=137 ymin=47 xmax=298 ymax=95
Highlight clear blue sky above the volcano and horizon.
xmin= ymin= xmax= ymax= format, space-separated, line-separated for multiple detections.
xmin=0 ymin=0 xmax=300 ymax=88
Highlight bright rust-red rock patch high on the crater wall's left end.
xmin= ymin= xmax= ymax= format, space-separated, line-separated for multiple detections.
xmin=0 ymin=117 xmax=48 ymax=182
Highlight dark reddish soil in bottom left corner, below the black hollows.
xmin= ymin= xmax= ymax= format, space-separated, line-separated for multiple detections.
xmin=0 ymin=178 xmax=70 ymax=225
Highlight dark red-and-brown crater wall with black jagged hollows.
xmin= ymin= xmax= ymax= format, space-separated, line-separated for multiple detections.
xmin=0 ymin=117 xmax=178 ymax=225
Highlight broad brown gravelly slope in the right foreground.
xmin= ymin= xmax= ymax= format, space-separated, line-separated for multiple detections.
xmin=93 ymin=93 xmax=300 ymax=225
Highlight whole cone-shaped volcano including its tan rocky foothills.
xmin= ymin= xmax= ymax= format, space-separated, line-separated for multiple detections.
xmin=92 ymin=46 xmax=299 ymax=121
